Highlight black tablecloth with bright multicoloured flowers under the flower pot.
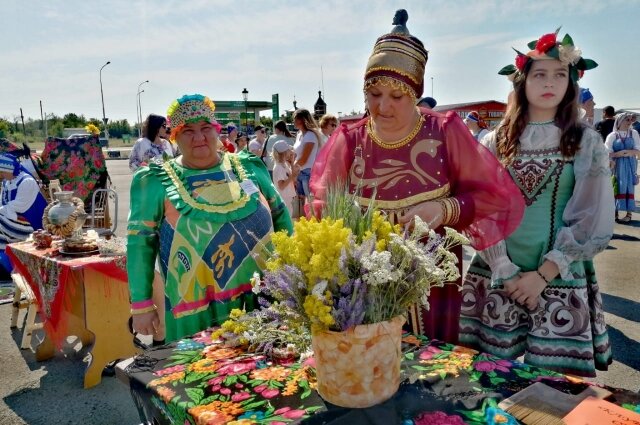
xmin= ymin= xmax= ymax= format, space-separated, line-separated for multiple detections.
xmin=126 ymin=330 xmax=640 ymax=425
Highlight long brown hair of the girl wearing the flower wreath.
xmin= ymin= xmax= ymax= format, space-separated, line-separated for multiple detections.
xmin=496 ymin=61 xmax=584 ymax=164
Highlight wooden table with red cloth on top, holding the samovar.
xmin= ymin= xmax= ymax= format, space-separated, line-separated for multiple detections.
xmin=6 ymin=242 xmax=139 ymax=388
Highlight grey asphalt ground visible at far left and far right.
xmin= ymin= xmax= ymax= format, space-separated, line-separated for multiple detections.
xmin=0 ymin=160 xmax=640 ymax=425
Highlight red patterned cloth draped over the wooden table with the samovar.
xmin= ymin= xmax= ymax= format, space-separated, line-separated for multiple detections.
xmin=6 ymin=242 xmax=128 ymax=346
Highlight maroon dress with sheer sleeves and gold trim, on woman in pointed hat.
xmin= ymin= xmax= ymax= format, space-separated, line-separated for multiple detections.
xmin=310 ymin=108 xmax=524 ymax=343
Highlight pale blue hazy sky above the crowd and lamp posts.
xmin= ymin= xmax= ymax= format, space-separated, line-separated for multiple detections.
xmin=0 ymin=0 xmax=640 ymax=123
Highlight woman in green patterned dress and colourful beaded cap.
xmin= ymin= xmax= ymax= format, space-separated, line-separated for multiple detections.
xmin=127 ymin=95 xmax=292 ymax=341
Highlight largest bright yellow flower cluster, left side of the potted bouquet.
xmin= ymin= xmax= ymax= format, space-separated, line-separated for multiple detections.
xmin=267 ymin=218 xmax=351 ymax=289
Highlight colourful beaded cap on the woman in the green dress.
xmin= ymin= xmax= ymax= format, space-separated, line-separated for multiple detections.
xmin=167 ymin=94 xmax=222 ymax=141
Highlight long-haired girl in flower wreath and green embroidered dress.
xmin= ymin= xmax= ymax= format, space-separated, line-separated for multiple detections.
xmin=460 ymin=31 xmax=614 ymax=376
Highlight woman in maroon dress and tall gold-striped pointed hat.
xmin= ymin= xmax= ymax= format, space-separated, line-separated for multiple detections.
xmin=311 ymin=10 xmax=524 ymax=342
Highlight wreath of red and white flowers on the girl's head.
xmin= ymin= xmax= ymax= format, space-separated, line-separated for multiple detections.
xmin=498 ymin=28 xmax=598 ymax=83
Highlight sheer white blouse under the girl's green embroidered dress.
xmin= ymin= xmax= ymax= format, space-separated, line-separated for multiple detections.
xmin=478 ymin=124 xmax=614 ymax=285
